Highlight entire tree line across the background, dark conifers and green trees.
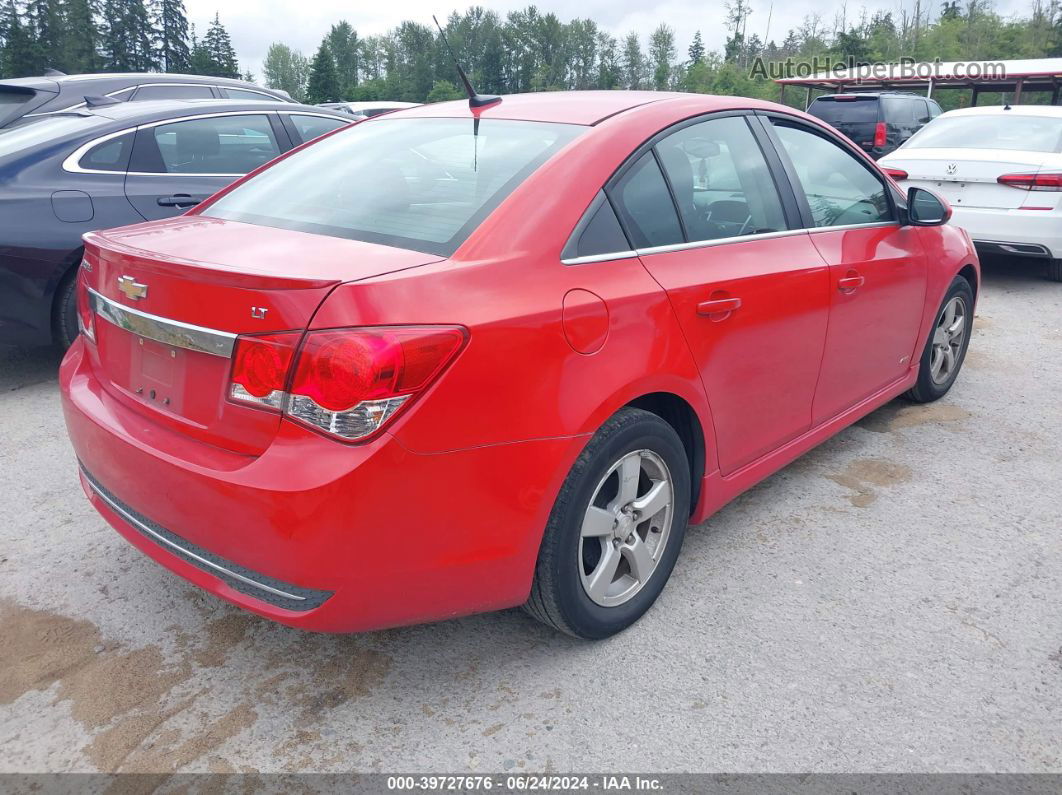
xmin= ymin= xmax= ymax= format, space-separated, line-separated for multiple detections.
xmin=0 ymin=0 xmax=1062 ymax=107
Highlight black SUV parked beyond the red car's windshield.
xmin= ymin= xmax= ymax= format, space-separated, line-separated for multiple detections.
xmin=807 ymin=91 xmax=941 ymax=159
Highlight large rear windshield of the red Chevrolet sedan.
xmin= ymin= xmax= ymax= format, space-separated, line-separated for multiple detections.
xmin=202 ymin=117 xmax=585 ymax=257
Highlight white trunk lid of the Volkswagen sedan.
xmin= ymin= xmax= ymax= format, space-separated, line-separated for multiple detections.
xmin=881 ymin=148 xmax=1046 ymax=209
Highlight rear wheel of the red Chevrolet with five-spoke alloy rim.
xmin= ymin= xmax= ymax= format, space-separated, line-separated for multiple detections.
xmin=524 ymin=409 xmax=690 ymax=640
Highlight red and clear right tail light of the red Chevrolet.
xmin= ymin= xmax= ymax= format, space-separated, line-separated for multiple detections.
xmin=229 ymin=326 xmax=467 ymax=442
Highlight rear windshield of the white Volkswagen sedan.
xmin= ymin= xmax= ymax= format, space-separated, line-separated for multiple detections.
xmin=903 ymin=111 xmax=1062 ymax=152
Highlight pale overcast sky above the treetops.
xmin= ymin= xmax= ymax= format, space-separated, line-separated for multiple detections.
xmin=185 ymin=0 xmax=1031 ymax=81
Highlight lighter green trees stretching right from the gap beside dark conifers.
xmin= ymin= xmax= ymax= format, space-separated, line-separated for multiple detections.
xmin=263 ymin=0 xmax=1062 ymax=106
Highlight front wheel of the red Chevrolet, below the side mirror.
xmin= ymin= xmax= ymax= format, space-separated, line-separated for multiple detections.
xmin=904 ymin=276 xmax=974 ymax=403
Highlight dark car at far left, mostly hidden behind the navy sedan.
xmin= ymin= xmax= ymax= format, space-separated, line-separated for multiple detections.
xmin=0 ymin=71 xmax=292 ymax=127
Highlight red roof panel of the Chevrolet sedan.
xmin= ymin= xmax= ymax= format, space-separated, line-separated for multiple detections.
xmin=387 ymin=91 xmax=739 ymax=124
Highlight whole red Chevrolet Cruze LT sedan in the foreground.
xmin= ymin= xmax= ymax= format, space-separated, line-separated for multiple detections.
xmin=62 ymin=91 xmax=979 ymax=638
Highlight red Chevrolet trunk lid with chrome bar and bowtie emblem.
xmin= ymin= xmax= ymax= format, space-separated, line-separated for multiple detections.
xmin=84 ymin=215 xmax=440 ymax=455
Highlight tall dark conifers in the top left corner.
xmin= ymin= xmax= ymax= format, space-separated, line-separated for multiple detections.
xmin=0 ymin=0 xmax=243 ymax=77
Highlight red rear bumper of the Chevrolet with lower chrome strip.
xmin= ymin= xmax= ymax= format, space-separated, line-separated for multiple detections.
xmin=59 ymin=340 xmax=582 ymax=632
